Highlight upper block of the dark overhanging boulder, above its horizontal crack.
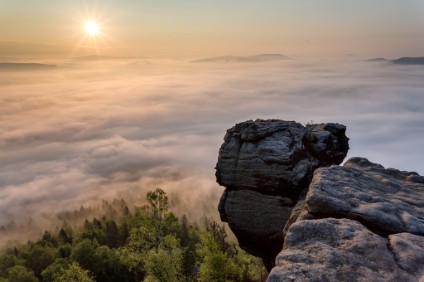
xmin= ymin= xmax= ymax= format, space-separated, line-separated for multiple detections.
xmin=216 ymin=120 xmax=349 ymax=195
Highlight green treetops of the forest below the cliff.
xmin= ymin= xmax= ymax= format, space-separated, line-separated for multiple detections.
xmin=0 ymin=188 xmax=265 ymax=282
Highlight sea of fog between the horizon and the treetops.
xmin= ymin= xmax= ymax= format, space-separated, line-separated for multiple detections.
xmin=0 ymin=58 xmax=424 ymax=245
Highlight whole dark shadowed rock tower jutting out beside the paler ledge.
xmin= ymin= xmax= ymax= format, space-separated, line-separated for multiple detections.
xmin=216 ymin=120 xmax=349 ymax=268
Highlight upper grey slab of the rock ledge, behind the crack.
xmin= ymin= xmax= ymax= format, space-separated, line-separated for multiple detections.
xmin=298 ymin=158 xmax=424 ymax=236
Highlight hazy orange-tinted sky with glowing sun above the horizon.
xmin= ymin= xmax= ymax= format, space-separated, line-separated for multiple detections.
xmin=0 ymin=0 xmax=424 ymax=57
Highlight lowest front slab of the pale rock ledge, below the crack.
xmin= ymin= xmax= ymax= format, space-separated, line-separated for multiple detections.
xmin=268 ymin=218 xmax=423 ymax=282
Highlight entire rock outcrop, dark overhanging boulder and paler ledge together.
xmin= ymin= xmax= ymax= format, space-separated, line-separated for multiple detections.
xmin=216 ymin=120 xmax=424 ymax=282
